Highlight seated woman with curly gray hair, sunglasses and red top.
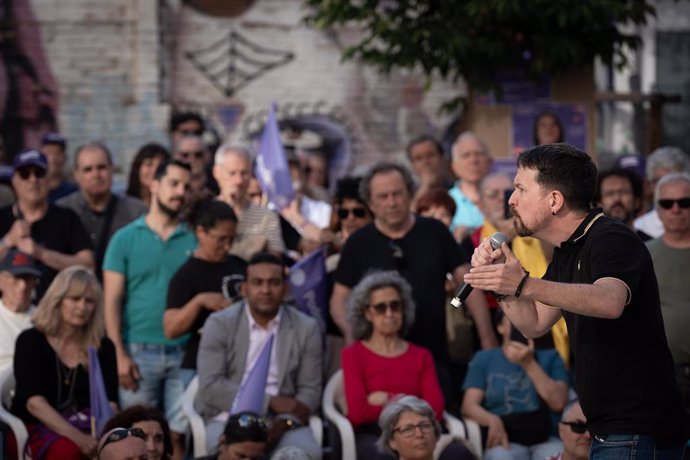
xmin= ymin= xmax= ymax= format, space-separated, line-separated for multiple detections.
xmin=342 ymin=271 xmax=469 ymax=459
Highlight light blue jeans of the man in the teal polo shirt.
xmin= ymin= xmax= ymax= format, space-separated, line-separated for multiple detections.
xmin=120 ymin=343 xmax=187 ymax=433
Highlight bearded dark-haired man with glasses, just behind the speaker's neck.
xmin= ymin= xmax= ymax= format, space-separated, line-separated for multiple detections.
xmin=595 ymin=168 xmax=651 ymax=241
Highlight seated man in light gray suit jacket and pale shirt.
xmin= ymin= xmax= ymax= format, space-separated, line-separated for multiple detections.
xmin=197 ymin=253 xmax=323 ymax=459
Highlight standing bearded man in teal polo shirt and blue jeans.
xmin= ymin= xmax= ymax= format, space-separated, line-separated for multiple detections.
xmin=103 ymin=160 xmax=196 ymax=459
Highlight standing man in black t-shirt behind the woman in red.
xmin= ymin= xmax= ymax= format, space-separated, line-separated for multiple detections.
xmin=330 ymin=163 xmax=498 ymax=406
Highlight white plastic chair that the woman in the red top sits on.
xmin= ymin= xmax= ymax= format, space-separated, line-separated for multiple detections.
xmin=322 ymin=369 xmax=481 ymax=460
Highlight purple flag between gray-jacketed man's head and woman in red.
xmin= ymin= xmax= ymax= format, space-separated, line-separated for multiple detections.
xmin=289 ymin=248 xmax=328 ymax=335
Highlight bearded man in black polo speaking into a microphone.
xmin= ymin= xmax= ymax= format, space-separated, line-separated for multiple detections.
xmin=464 ymin=144 xmax=687 ymax=459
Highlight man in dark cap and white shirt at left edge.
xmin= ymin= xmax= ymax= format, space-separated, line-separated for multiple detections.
xmin=0 ymin=249 xmax=41 ymax=372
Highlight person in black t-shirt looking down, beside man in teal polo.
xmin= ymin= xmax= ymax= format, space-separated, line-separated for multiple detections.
xmin=163 ymin=200 xmax=247 ymax=376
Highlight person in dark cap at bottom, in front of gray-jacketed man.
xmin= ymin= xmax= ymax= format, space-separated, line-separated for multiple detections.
xmin=198 ymin=411 xmax=268 ymax=460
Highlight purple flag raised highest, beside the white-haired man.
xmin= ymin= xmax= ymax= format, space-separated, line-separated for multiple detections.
xmin=256 ymin=104 xmax=295 ymax=211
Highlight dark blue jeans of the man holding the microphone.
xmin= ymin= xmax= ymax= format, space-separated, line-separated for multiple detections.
xmin=589 ymin=434 xmax=685 ymax=460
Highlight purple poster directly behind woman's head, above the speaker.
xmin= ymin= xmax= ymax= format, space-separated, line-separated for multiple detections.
xmin=512 ymin=102 xmax=587 ymax=156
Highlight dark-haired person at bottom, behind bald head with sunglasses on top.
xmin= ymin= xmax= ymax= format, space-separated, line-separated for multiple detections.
xmin=101 ymin=404 xmax=173 ymax=460
